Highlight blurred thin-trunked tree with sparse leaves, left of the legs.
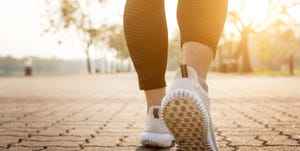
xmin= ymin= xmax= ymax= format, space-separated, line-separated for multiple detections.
xmin=41 ymin=0 xmax=104 ymax=73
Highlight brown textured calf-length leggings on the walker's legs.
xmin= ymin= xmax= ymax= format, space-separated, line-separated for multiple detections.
xmin=124 ymin=0 xmax=228 ymax=90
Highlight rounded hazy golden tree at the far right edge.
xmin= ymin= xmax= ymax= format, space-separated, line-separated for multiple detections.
xmin=252 ymin=24 xmax=300 ymax=75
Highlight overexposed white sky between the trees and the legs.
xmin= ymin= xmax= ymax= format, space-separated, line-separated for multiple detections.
xmin=0 ymin=0 xmax=300 ymax=59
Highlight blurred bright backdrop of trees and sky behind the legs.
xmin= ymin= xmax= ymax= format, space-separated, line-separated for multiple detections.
xmin=0 ymin=0 xmax=300 ymax=76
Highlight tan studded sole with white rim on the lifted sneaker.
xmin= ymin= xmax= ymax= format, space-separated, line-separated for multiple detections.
xmin=162 ymin=89 xmax=217 ymax=151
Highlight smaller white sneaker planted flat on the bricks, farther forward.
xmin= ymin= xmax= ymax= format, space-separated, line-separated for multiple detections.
xmin=140 ymin=106 xmax=174 ymax=147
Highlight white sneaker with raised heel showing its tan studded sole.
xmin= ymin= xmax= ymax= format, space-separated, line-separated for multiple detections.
xmin=162 ymin=65 xmax=218 ymax=151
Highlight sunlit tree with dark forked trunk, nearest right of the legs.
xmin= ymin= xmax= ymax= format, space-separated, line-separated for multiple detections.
xmin=227 ymin=0 xmax=300 ymax=72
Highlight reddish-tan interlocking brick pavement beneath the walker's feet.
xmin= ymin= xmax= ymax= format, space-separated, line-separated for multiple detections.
xmin=0 ymin=72 xmax=300 ymax=151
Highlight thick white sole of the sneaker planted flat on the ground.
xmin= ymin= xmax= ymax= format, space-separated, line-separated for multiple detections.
xmin=140 ymin=132 xmax=173 ymax=148
